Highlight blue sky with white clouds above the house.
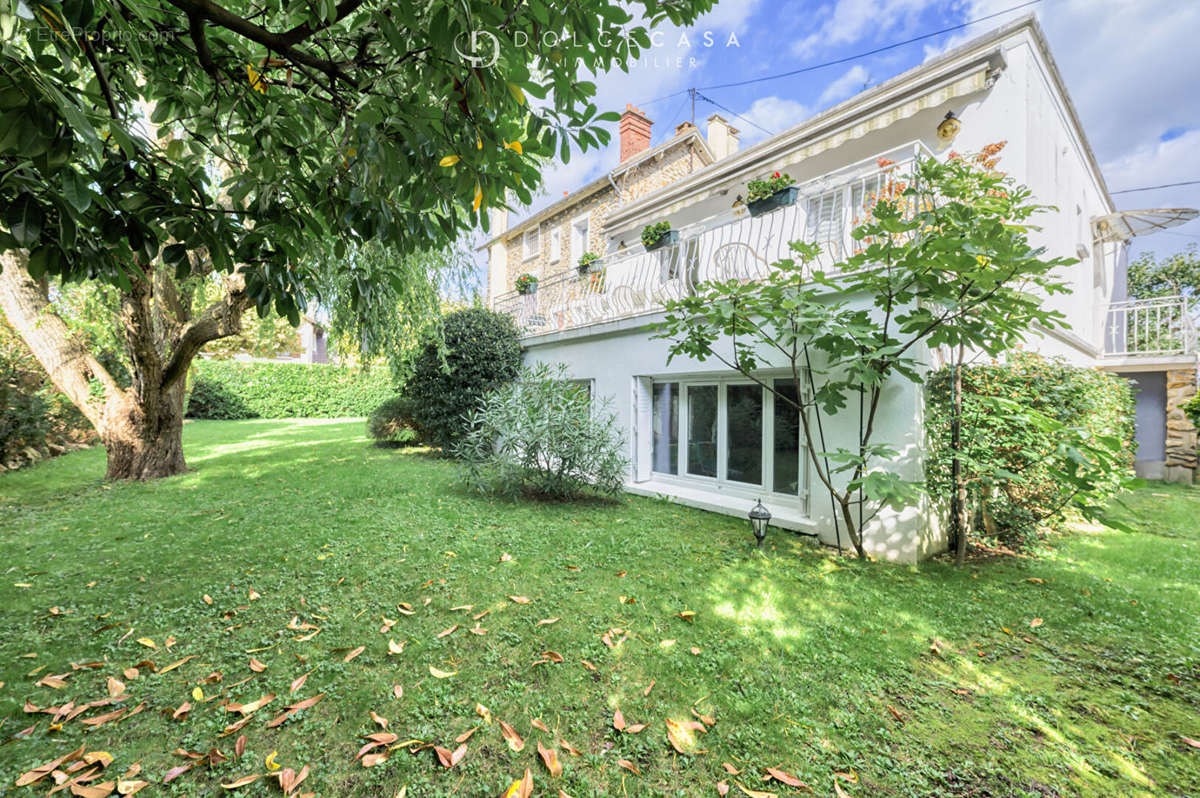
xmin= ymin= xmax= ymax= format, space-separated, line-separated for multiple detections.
xmin=481 ymin=0 xmax=1200 ymax=286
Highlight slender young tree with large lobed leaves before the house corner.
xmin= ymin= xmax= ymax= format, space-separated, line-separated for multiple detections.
xmin=660 ymin=144 xmax=1075 ymax=557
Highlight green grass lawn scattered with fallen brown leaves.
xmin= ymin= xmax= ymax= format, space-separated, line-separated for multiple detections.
xmin=0 ymin=421 xmax=1200 ymax=798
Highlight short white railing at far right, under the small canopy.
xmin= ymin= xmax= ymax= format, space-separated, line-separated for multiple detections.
xmin=1104 ymin=296 xmax=1196 ymax=356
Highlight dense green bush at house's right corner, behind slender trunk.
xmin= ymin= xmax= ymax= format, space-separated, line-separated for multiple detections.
xmin=925 ymin=352 xmax=1133 ymax=548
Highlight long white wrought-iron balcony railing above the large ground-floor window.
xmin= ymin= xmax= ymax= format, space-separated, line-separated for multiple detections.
xmin=494 ymin=150 xmax=916 ymax=335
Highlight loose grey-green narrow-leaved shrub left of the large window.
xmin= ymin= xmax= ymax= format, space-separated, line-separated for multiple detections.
xmin=456 ymin=365 xmax=626 ymax=499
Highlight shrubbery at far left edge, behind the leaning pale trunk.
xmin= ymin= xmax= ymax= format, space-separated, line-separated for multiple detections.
xmin=0 ymin=320 xmax=95 ymax=470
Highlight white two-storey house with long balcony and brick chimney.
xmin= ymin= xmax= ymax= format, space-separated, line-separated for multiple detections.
xmin=485 ymin=17 xmax=1196 ymax=562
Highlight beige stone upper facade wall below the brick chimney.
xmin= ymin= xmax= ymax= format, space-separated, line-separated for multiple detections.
xmin=494 ymin=134 xmax=706 ymax=294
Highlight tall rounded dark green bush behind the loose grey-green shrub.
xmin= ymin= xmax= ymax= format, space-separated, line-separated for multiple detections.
xmin=403 ymin=307 xmax=521 ymax=452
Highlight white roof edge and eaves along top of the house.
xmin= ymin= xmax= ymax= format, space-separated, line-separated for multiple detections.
xmin=608 ymin=14 xmax=1114 ymax=233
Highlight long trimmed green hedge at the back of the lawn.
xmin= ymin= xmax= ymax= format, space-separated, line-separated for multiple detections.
xmin=187 ymin=360 xmax=395 ymax=419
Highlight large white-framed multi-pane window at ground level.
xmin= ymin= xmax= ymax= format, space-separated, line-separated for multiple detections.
xmin=646 ymin=378 xmax=808 ymax=510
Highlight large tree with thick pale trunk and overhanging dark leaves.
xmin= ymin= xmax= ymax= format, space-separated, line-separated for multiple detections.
xmin=0 ymin=0 xmax=712 ymax=479
